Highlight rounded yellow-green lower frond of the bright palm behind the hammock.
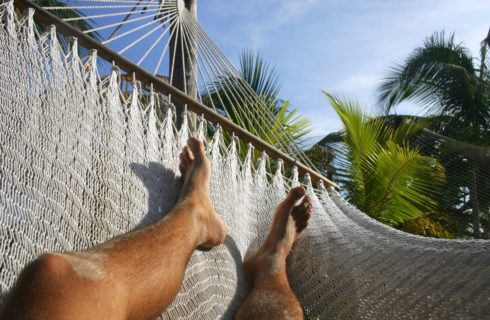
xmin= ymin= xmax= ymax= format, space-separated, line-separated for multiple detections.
xmin=365 ymin=142 xmax=444 ymax=225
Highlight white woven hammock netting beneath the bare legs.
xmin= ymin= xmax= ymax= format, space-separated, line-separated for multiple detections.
xmin=0 ymin=2 xmax=490 ymax=319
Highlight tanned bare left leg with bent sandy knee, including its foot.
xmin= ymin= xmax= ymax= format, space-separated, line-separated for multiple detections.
xmin=0 ymin=138 xmax=226 ymax=320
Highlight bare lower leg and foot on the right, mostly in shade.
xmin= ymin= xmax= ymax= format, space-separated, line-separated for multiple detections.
xmin=236 ymin=187 xmax=311 ymax=320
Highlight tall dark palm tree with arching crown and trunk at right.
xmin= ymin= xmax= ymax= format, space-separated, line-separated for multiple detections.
xmin=378 ymin=31 xmax=490 ymax=238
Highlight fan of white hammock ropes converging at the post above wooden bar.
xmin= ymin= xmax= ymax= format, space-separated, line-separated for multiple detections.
xmin=31 ymin=0 xmax=322 ymax=169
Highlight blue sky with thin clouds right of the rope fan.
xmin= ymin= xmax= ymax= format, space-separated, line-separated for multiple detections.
xmin=198 ymin=0 xmax=490 ymax=140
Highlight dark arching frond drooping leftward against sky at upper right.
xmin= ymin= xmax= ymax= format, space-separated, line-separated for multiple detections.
xmin=377 ymin=31 xmax=475 ymax=112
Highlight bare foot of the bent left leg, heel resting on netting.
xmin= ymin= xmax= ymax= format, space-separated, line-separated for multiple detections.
xmin=179 ymin=138 xmax=227 ymax=249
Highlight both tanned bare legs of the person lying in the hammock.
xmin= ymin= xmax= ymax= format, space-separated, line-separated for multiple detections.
xmin=0 ymin=138 xmax=311 ymax=320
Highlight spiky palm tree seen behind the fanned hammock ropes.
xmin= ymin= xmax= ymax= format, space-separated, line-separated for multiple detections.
xmin=202 ymin=51 xmax=311 ymax=159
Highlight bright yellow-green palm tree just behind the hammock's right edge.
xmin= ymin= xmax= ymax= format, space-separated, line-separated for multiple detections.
xmin=320 ymin=93 xmax=444 ymax=227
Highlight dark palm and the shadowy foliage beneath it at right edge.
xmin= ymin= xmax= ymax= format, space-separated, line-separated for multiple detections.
xmin=378 ymin=32 xmax=490 ymax=238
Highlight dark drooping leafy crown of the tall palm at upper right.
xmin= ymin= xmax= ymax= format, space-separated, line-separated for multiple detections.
xmin=378 ymin=32 xmax=490 ymax=138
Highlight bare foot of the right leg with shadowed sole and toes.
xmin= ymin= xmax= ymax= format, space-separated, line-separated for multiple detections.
xmin=244 ymin=187 xmax=312 ymax=285
